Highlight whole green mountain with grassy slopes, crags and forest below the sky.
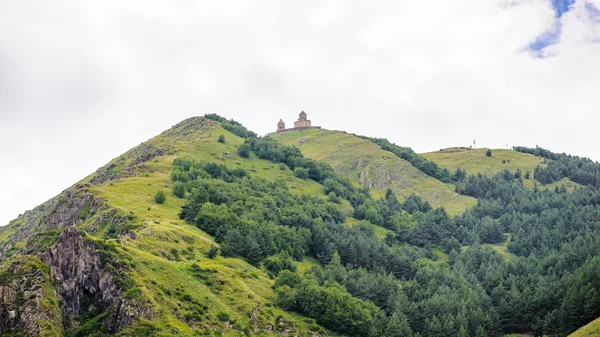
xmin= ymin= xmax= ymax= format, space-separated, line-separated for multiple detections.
xmin=0 ymin=115 xmax=600 ymax=336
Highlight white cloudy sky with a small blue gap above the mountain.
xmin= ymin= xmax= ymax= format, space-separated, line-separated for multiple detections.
xmin=0 ymin=0 xmax=600 ymax=224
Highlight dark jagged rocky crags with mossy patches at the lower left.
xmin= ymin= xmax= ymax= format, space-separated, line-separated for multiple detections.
xmin=0 ymin=227 xmax=154 ymax=336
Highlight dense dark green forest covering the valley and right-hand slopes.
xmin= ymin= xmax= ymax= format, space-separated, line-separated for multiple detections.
xmin=193 ymin=114 xmax=600 ymax=336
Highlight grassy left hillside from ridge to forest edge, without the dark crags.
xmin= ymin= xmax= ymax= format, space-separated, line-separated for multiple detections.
xmin=0 ymin=118 xmax=338 ymax=336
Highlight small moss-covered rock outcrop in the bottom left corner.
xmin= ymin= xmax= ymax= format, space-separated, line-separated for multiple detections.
xmin=0 ymin=256 xmax=62 ymax=336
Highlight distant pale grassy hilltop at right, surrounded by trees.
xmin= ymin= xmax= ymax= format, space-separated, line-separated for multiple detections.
xmin=421 ymin=148 xmax=579 ymax=189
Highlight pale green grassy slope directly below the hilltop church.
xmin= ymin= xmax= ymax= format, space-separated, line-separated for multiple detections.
xmin=274 ymin=129 xmax=476 ymax=214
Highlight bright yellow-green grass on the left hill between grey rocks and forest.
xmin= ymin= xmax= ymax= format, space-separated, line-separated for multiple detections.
xmin=86 ymin=120 xmax=336 ymax=336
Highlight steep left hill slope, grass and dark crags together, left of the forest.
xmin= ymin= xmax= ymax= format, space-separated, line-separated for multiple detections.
xmin=0 ymin=117 xmax=332 ymax=336
